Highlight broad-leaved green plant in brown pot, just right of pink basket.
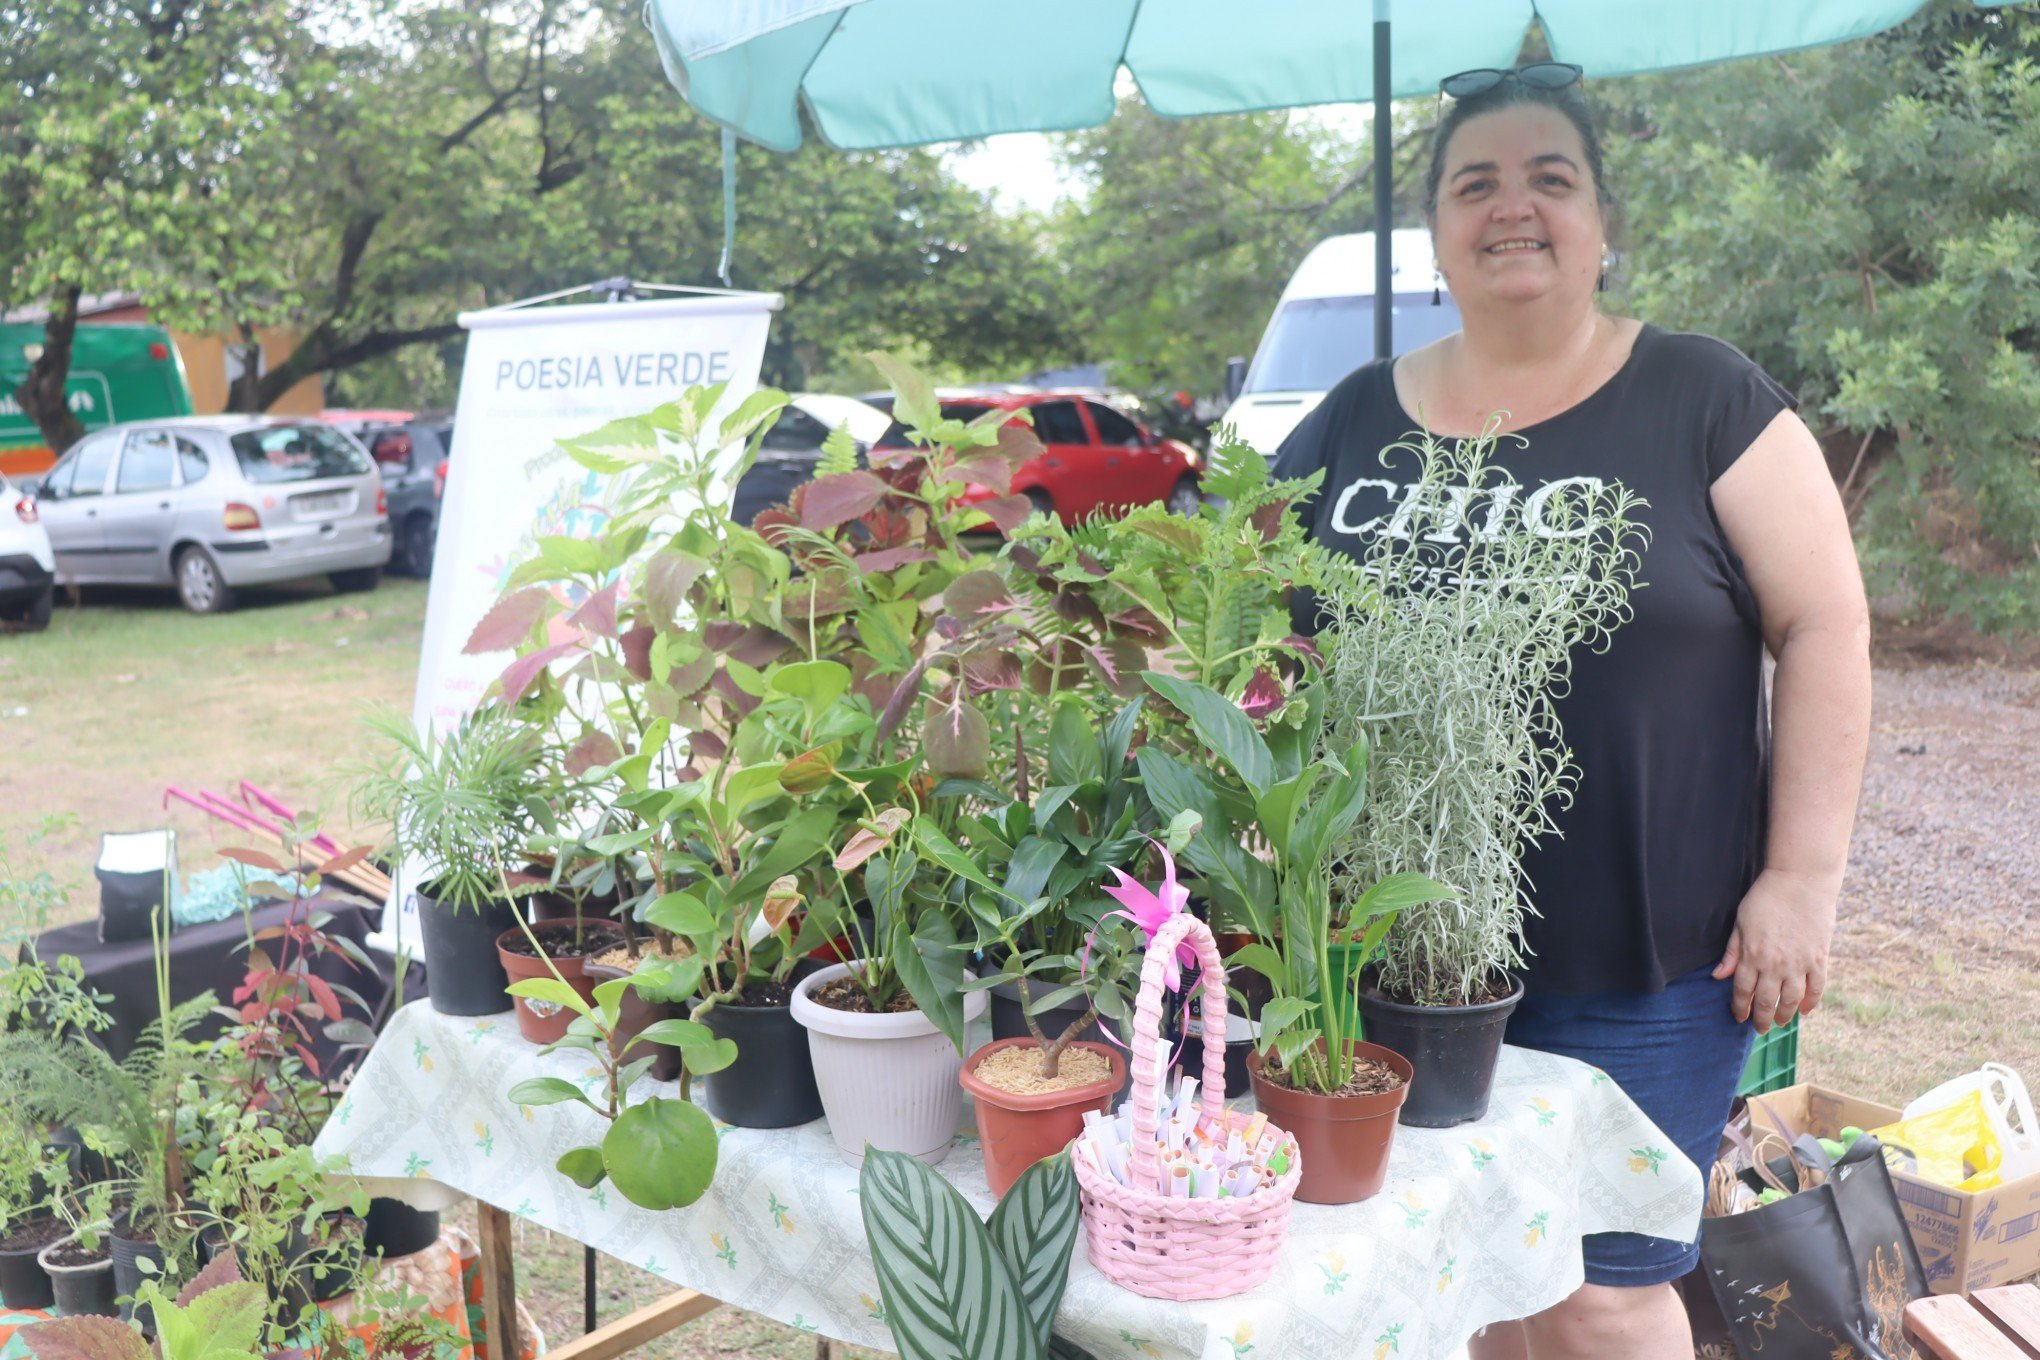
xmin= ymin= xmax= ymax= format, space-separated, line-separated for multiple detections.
xmin=1140 ymin=671 xmax=1446 ymax=1203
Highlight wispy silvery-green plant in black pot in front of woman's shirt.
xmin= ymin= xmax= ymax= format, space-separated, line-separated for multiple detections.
xmin=1320 ymin=436 xmax=1644 ymax=1128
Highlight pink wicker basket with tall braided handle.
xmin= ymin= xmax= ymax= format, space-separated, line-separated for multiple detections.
xmin=1073 ymin=916 xmax=1302 ymax=1299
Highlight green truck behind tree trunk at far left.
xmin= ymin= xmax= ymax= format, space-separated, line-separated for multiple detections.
xmin=0 ymin=322 xmax=192 ymax=475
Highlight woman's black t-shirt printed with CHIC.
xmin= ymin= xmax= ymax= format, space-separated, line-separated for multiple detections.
xmin=1275 ymin=326 xmax=1797 ymax=993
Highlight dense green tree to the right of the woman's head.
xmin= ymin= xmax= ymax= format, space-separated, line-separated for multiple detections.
xmin=1599 ymin=4 xmax=2040 ymax=628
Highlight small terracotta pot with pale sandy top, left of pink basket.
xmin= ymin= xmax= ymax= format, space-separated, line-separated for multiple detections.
xmin=957 ymin=1038 xmax=1126 ymax=1195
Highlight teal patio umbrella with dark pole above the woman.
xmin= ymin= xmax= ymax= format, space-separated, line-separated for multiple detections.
xmin=645 ymin=0 xmax=2009 ymax=355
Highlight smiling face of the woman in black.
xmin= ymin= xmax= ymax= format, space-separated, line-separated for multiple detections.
xmin=1432 ymin=104 xmax=1608 ymax=308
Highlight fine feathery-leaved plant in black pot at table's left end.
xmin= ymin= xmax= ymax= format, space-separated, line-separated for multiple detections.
xmin=353 ymin=705 xmax=545 ymax=1015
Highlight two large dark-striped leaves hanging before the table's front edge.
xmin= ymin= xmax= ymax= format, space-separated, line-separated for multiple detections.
xmin=857 ymin=1148 xmax=1081 ymax=1360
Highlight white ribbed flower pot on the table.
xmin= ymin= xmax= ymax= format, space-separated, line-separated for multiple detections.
xmin=794 ymin=962 xmax=985 ymax=1166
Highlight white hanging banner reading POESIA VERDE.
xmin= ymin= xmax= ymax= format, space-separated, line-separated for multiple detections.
xmin=379 ymin=294 xmax=779 ymax=952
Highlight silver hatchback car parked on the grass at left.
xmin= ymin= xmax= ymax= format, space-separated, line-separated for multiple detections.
xmin=37 ymin=416 xmax=390 ymax=614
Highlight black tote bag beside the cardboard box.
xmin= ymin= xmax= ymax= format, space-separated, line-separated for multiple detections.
xmin=1699 ymin=1138 xmax=1928 ymax=1360
